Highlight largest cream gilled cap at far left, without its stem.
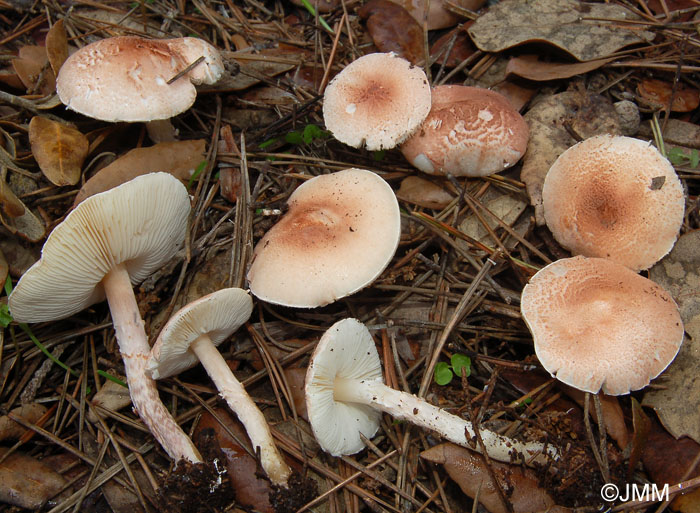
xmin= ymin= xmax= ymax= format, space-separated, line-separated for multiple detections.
xmin=9 ymin=173 xmax=190 ymax=322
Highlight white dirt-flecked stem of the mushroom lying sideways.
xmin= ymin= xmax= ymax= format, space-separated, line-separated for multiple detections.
xmin=333 ymin=377 xmax=558 ymax=464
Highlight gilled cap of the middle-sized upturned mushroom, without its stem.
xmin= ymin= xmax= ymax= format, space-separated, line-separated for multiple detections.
xmin=146 ymin=288 xmax=253 ymax=379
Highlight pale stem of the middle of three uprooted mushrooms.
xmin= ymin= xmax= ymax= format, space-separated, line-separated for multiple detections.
xmin=190 ymin=333 xmax=292 ymax=488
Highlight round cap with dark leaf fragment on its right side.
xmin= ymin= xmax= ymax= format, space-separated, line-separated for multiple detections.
xmin=542 ymin=135 xmax=685 ymax=271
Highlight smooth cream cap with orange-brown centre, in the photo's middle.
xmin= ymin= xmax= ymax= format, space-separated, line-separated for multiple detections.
xmin=248 ymin=168 xmax=401 ymax=308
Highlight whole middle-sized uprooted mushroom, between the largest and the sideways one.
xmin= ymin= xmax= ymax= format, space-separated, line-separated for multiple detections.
xmin=147 ymin=288 xmax=291 ymax=487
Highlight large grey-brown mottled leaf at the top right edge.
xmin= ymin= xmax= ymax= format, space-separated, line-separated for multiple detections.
xmin=469 ymin=0 xmax=654 ymax=61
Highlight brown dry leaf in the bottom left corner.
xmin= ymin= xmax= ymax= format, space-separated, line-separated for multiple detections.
xmin=0 ymin=447 xmax=66 ymax=510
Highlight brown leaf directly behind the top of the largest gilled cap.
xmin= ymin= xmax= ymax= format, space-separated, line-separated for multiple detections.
xmin=73 ymin=139 xmax=206 ymax=207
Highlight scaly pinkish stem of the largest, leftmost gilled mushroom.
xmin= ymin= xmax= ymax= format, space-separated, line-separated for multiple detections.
xmin=102 ymin=264 xmax=202 ymax=463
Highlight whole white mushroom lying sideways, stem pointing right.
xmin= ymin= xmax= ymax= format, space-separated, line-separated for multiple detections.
xmin=305 ymin=319 xmax=558 ymax=464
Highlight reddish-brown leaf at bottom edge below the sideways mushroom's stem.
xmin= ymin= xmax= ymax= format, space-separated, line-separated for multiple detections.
xmin=420 ymin=443 xmax=554 ymax=513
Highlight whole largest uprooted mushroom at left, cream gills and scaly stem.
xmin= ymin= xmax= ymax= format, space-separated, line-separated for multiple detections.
xmin=8 ymin=173 xmax=201 ymax=462
